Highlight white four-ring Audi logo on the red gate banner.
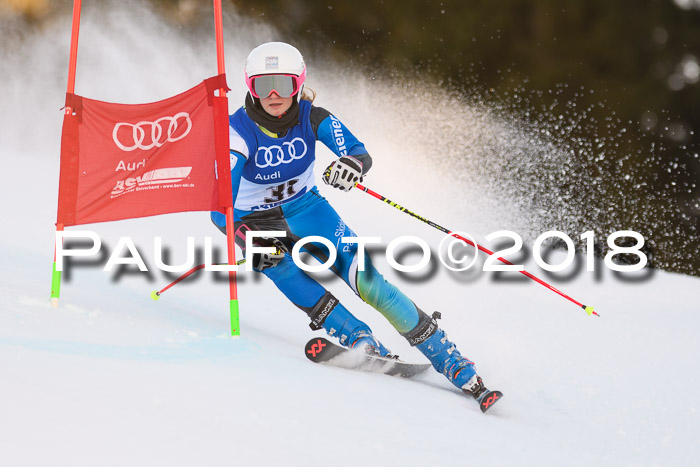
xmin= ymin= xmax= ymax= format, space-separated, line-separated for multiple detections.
xmin=112 ymin=112 xmax=192 ymax=152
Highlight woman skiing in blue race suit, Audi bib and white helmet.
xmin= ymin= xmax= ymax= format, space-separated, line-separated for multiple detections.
xmin=212 ymin=42 xmax=486 ymax=399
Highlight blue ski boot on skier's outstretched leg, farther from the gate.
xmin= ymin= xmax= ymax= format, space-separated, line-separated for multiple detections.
xmin=403 ymin=310 xmax=483 ymax=393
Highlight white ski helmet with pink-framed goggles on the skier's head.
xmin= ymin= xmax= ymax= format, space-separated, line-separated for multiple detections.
xmin=245 ymin=42 xmax=306 ymax=98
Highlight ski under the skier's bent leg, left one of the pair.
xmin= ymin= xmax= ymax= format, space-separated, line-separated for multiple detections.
xmin=304 ymin=337 xmax=432 ymax=378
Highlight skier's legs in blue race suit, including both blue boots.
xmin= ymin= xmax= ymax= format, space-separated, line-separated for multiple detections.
xmin=212 ymin=187 xmax=476 ymax=388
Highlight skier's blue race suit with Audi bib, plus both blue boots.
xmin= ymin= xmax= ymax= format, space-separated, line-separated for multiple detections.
xmin=212 ymin=100 xmax=476 ymax=387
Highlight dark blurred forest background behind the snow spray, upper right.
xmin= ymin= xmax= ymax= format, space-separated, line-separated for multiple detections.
xmin=5 ymin=0 xmax=700 ymax=275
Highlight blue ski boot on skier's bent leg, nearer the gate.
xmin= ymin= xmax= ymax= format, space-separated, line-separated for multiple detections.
xmin=307 ymin=292 xmax=394 ymax=358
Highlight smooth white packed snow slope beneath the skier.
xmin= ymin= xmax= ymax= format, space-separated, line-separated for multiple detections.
xmin=0 ymin=172 xmax=700 ymax=466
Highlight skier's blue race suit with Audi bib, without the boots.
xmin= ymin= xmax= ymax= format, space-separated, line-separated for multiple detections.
xmin=212 ymin=100 xmax=419 ymax=336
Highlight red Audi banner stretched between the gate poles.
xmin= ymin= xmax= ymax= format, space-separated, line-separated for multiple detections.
xmin=58 ymin=77 xmax=232 ymax=226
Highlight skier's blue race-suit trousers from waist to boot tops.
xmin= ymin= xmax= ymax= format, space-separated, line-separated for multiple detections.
xmin=221 ymin=187 xmax=420 ymax=334
